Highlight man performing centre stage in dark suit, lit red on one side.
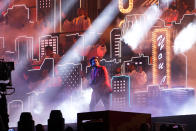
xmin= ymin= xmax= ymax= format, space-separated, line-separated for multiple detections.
xmin=89 ymin=57 xmax=112 ymax=111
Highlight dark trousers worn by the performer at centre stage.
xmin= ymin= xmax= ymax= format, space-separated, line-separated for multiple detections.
xmin=89 ymin=90 xmax=110 ymax=111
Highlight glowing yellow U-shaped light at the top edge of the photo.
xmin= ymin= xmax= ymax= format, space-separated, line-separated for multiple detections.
xmin=118 ymin=0 xmax=133 ymax=14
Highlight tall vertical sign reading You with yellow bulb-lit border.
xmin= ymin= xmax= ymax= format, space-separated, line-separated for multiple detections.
xmin=152 ymin=28 xmax=171 ymax=86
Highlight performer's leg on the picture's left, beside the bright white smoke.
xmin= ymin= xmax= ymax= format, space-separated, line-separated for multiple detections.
xmin=89 ymin=91 xmax=101 ymax=111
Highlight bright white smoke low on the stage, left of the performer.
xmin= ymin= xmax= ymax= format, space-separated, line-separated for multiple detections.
xmin=9 ymin=89 xmax=92 ymax=127
